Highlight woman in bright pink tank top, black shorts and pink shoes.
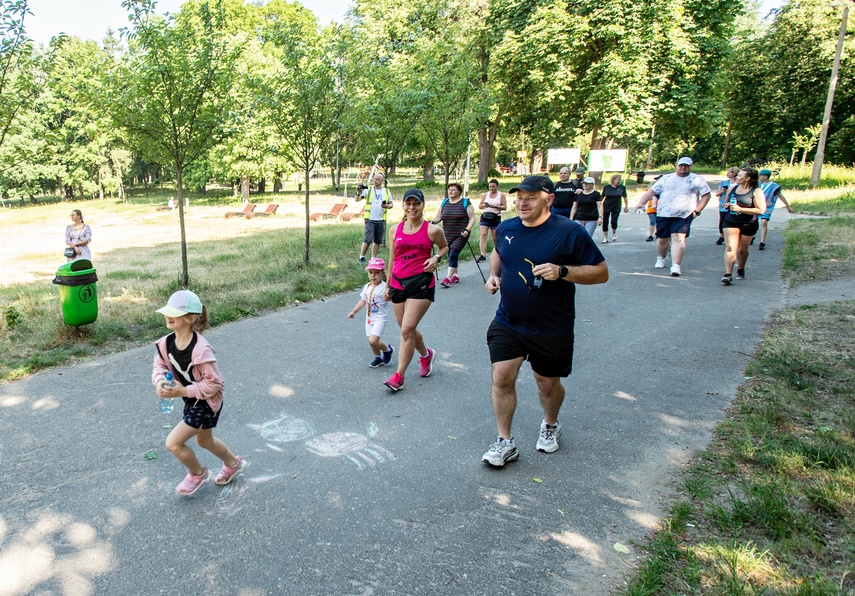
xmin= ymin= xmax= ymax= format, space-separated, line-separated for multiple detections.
xmin=383 ymin=188 xmax=448 ymax=391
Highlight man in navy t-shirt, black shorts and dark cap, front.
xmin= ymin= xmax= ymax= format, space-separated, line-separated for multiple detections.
xmin=482 ymin=176 xmax=609 ymax=467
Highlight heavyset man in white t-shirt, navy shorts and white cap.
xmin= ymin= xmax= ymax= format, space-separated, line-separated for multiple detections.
xmin=635 ymin=157 xmax=710 ymax=277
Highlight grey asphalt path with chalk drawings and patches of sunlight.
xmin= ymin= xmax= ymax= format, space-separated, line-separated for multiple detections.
xmin=0 ymin=205 xmax=787 ymax=596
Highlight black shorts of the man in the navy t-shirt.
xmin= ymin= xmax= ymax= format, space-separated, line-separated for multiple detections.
xmin=487 ymin=321 xmax=573 ymax=377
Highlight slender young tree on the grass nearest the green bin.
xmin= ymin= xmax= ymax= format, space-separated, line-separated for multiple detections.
xmin=107 ymin=0 xmax=243 ymax=287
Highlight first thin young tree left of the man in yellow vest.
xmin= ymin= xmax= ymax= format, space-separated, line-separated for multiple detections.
xmin=258 ymin=0 xmax=345 ymax=265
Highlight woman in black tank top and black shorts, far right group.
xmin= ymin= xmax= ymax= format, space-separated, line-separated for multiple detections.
xmin=721 ymin=168 xmax=766 ymax=286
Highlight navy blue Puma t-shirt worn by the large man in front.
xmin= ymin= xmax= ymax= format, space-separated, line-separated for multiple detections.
xmin=496 ymin=214 xmax=605 ymax=335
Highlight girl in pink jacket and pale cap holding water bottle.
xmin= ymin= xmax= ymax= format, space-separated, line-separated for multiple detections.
xmin=151 ymin=290 xmax=248 ymax=496
